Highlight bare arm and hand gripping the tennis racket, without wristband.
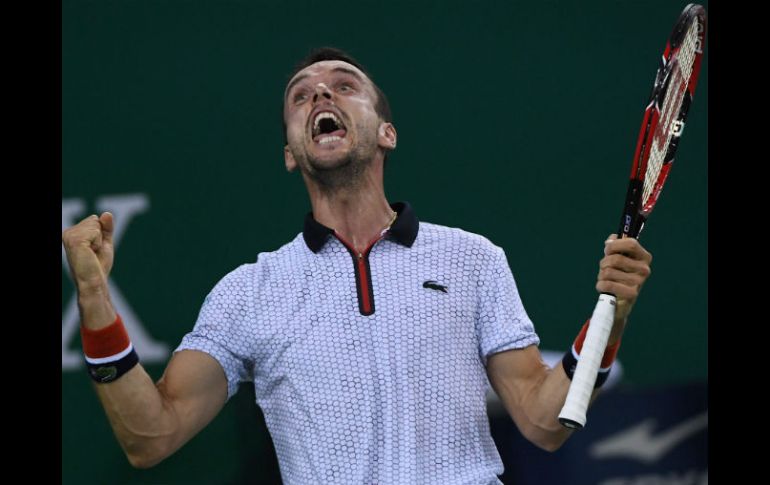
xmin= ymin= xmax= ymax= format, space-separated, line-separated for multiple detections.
xmin=487 ymin=236 xmax=652 ymax=451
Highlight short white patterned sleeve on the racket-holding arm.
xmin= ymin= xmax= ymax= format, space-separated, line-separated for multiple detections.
xmin=476 ymin=246 xmax=540 ymax=365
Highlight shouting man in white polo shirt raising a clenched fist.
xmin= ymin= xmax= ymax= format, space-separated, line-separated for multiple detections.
xmin=62 ymin=49 xmax=651 ymax=484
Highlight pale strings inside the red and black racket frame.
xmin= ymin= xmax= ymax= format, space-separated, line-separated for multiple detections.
xmin=642 ymin=19 xmax=701 ymax=204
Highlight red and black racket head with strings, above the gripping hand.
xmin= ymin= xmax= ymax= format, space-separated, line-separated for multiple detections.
xmin=618 ymin=4 xmax=706 ymax=237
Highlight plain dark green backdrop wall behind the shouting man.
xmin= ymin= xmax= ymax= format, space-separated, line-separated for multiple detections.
xmin=62 ymin=0 xmax=708 ymax=484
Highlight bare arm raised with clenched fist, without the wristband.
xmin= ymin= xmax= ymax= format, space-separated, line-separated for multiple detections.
xmin=62 ymin=213 xmax=227 ymax=468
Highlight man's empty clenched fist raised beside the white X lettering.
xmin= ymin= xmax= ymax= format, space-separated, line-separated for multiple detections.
xmin=62 ymin=212 xmax=114 ymax=296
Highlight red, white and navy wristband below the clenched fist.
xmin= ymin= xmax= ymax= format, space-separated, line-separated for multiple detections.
xmin=80 ymin=315 xmax=139 ymax=384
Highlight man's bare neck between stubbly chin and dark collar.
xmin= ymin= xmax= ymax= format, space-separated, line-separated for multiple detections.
xmin=304 ymin=163 xmax=393 ymax=252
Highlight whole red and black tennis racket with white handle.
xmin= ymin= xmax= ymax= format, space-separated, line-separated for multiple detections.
xmin=559 ymin=3 xmax=706 ymax=429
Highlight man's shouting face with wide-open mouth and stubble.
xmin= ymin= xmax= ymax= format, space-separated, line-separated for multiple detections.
xmin=283 ymin=61 xmax=395 ymax=182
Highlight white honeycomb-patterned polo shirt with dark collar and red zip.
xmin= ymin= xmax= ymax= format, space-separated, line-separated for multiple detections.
xmin=176 ymin=203 xmax=540 ymax=485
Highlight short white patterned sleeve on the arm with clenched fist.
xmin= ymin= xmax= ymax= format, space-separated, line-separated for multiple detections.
xmin=174 ymin=265 xmax=255 ymax=399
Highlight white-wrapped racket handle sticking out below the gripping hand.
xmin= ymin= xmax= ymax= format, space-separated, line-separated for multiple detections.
xmin=559 ymin=293 xmax=617 ymax=429
